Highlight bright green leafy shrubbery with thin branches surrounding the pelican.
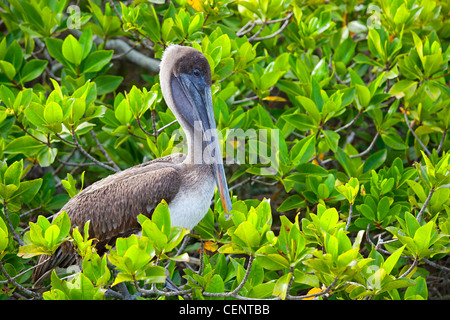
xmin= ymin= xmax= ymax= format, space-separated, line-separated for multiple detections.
xmin=0 ymin=0 xmax=450 ymax=299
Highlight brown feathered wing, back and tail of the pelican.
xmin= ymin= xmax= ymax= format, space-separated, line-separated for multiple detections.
xmin=33 ymin=154 xmax=186 ymax=284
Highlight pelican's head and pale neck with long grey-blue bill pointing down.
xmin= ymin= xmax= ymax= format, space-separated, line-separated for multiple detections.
xmin=159 ymin=45 xmax=231 ymax=213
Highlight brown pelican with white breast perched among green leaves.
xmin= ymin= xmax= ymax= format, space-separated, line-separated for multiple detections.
xmin=33 ymin=45 xmax=231 ymax=283
